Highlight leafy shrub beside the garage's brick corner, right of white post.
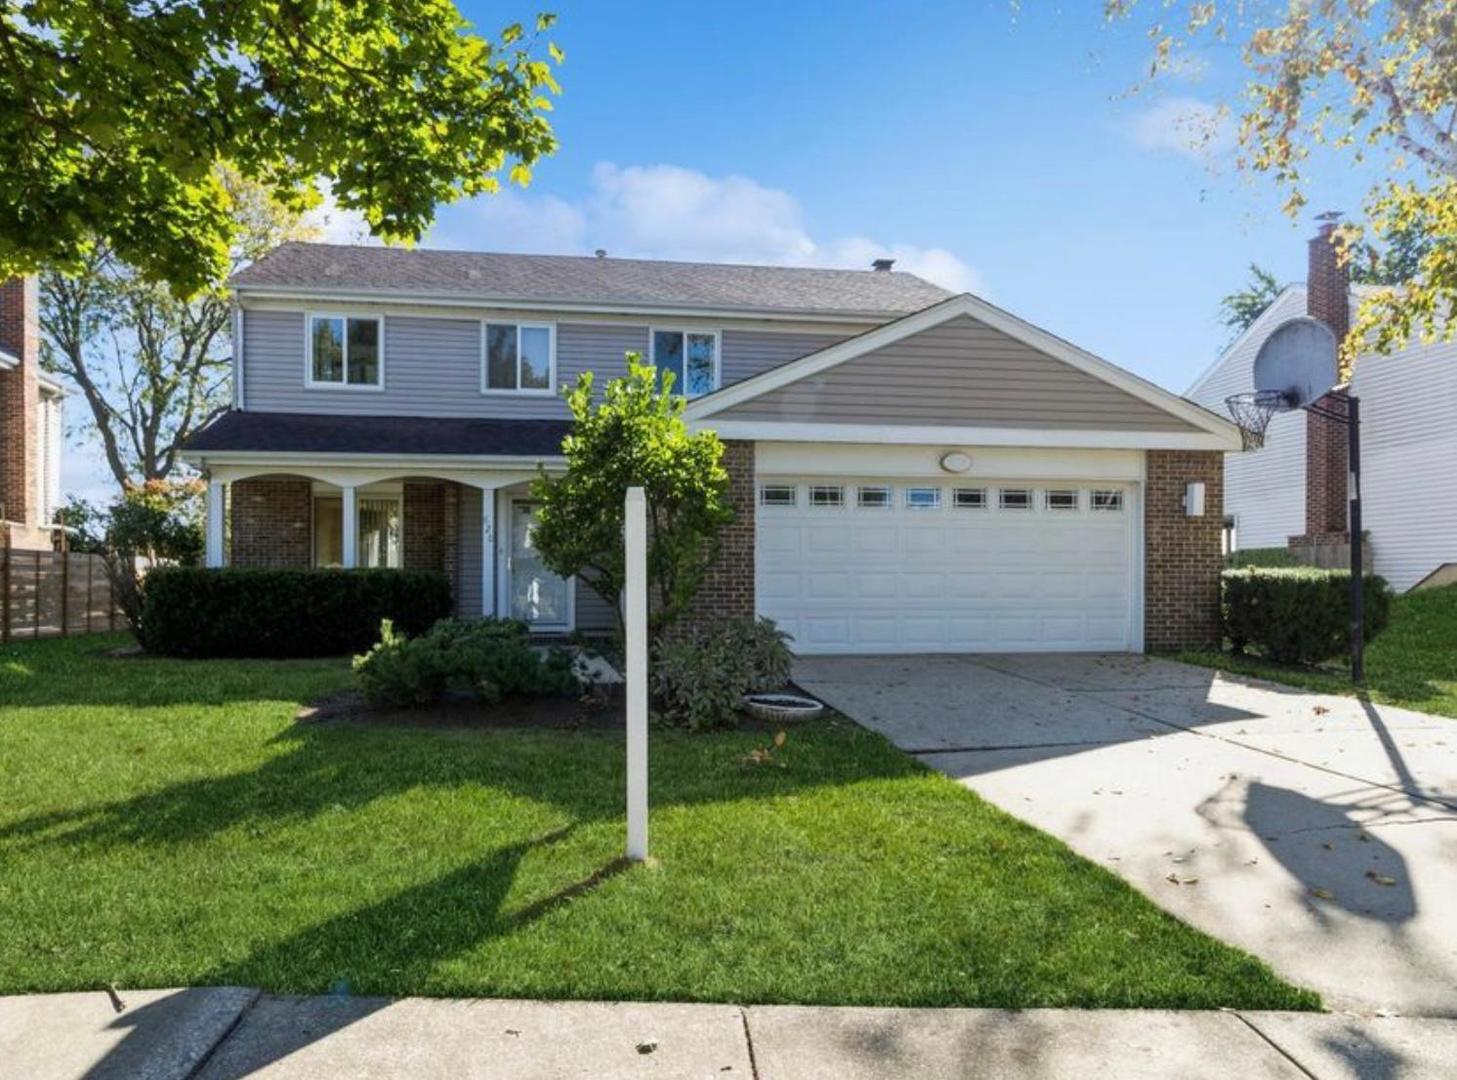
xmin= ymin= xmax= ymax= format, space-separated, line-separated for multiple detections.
xmin=651 ymin=618 xmax=794 ymax=732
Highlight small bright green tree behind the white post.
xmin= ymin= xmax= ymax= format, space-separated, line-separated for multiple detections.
xmin=533 ymin=353 xmax=733 ymax=635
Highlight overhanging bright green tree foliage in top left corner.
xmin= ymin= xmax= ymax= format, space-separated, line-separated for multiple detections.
xmin=0 ymin=0 xmax=561 ymax=294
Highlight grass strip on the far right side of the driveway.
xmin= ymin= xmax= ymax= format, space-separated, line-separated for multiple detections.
xmin=1174 ymin=584 xmax=1457 ymax=717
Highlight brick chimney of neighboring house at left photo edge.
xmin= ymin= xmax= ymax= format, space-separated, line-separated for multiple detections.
xmin=0 ymin=277 xmax=41 ymax=526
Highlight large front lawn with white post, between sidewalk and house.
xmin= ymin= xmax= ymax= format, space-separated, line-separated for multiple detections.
xmin=0 ymin=638 xmax=1319 ymax=1009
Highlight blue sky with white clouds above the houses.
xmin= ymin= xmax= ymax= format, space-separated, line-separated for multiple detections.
xmin=66 ymin=0 xmax=1367 ymax=494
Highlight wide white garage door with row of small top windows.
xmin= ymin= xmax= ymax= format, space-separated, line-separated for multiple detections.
xmin=756 ymin=477 xmax=1135 ymax=653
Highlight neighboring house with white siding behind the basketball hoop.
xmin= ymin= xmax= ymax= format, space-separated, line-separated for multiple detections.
xmin=1189 ymin=224 xmax=1457 ymax=589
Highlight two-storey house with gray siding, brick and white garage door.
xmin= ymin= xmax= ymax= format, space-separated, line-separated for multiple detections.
xmin=176 ymin=243 xmax=1238 ymax=653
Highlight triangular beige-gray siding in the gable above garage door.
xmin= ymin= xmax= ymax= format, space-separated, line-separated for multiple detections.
xmin=718 ymin=316 xmax=1195 ymax=431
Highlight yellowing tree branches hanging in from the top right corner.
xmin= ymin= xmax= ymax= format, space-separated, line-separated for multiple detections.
xmin=1104 ymin=0 xmax=1457 ymax=368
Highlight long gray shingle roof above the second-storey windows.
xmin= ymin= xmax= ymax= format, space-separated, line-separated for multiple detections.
xmin=233 ymin=242 xmax=951 ymax=316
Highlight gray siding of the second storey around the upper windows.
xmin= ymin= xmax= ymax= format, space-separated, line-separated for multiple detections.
xmin=243 ymin=310 xmax=842 ymax=420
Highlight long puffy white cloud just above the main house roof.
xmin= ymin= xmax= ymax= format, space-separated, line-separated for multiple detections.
xmin=430 ymin=162 xmax=982 ymax=291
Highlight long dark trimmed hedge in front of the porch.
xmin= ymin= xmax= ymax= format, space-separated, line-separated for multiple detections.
xmin=137 ymin=567 xmax=452 ymax=657
